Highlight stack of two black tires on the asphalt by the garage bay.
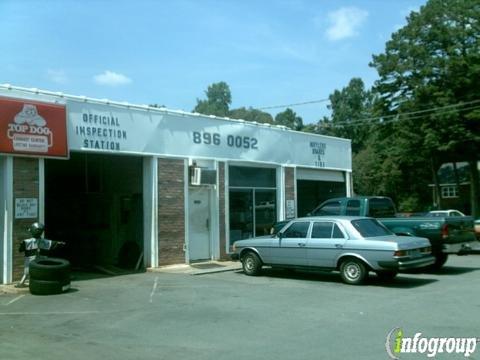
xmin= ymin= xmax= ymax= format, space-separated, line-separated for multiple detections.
xmin=28 ymin=257 xmax=70 ymax=295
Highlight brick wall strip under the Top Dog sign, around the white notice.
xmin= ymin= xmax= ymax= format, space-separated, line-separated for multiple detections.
xmin=12 ymin=157 xmax=39 ymax=281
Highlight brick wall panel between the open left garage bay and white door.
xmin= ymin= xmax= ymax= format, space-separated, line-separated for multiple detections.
xmin=158 ymin=159 xmax=185 ymax=266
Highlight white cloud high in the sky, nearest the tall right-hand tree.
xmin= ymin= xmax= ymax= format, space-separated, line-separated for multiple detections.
xmin=326 ymin=7 xmax=368 ymax=41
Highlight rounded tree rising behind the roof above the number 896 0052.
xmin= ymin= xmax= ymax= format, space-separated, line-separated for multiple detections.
xmin=193 ymin=81 xmax=232 ymax=117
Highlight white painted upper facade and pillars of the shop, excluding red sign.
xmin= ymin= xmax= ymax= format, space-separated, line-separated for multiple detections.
xmin=0 ymin=85 xmax=352 ymax=283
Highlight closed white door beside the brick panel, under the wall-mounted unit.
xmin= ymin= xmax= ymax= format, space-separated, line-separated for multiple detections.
xmin=188 ymin=188 xmax=211 ymax=261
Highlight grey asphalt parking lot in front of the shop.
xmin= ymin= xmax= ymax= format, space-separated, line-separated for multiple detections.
xmin=0 ymin=255 xmax=480 ymax=360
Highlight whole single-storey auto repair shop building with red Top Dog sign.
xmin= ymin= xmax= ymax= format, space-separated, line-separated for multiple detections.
xmin=0 ymin=85 xmax=352 ymax=284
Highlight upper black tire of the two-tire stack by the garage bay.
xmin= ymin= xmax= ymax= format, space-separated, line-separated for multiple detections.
xmin=28 ymin=258 xmax=70 ymax=282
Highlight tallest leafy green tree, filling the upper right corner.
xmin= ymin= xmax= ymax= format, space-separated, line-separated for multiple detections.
xmin=371 ymin=0 xmax=480 ymax=214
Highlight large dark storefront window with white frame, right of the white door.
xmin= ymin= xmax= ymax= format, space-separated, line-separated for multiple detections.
xmin=229 ymin=166 xmax=277 ymax=245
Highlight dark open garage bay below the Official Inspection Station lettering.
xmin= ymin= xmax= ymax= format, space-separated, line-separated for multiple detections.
xmin=45 ymin=153 xmax=144 ymax=274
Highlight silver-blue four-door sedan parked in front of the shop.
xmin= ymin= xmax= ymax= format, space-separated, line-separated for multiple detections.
xmin=232 ymin=216 xmax=435 ymax=285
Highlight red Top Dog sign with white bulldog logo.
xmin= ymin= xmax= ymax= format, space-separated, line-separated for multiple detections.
xmin=0 ymin=97 xmax=68 ymax=157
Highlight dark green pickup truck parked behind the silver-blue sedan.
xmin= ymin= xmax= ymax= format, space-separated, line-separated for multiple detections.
xmin=273 ymin=196 xmax=478 ymax=269
